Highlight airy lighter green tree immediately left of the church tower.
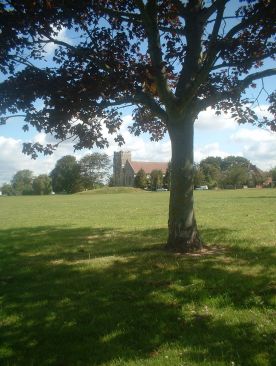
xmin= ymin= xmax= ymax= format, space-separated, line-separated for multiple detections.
xmin=79 ymin=153 xmax=110 ymax=189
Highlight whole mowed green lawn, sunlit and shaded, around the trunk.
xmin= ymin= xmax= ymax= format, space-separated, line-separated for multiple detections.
xmin=0 ymin=189 xmax=276 ymax=366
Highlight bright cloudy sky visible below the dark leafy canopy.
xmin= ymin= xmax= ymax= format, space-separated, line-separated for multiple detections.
xmin=0 ymin=13 xmax=276 ymax=186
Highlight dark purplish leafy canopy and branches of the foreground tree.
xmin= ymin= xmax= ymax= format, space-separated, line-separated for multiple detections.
xmin=0 ymin=0 xmax=276 ymax=157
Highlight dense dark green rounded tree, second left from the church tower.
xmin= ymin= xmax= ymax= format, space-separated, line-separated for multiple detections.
xmin=50 ymin=155 xmax=82 ymax=193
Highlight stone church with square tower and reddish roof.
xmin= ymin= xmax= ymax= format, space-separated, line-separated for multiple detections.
xmin=113 ymin=151 xmax=168 ymax=187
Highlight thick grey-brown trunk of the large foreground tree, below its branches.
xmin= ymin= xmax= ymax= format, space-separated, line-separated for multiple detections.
xmin=166 ymin=119 xmax=202 ymax=252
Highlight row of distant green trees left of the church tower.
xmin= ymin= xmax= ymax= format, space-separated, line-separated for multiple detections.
xmin=0 ymin=153 xmax=110 ymax=196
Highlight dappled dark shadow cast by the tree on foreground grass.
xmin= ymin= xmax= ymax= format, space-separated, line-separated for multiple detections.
xmin=0 ymin=227 xmax=276 ymax=366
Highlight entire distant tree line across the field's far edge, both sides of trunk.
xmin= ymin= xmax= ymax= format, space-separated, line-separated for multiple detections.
xmin=0 ymin=153 xmax=276 ymax=196
